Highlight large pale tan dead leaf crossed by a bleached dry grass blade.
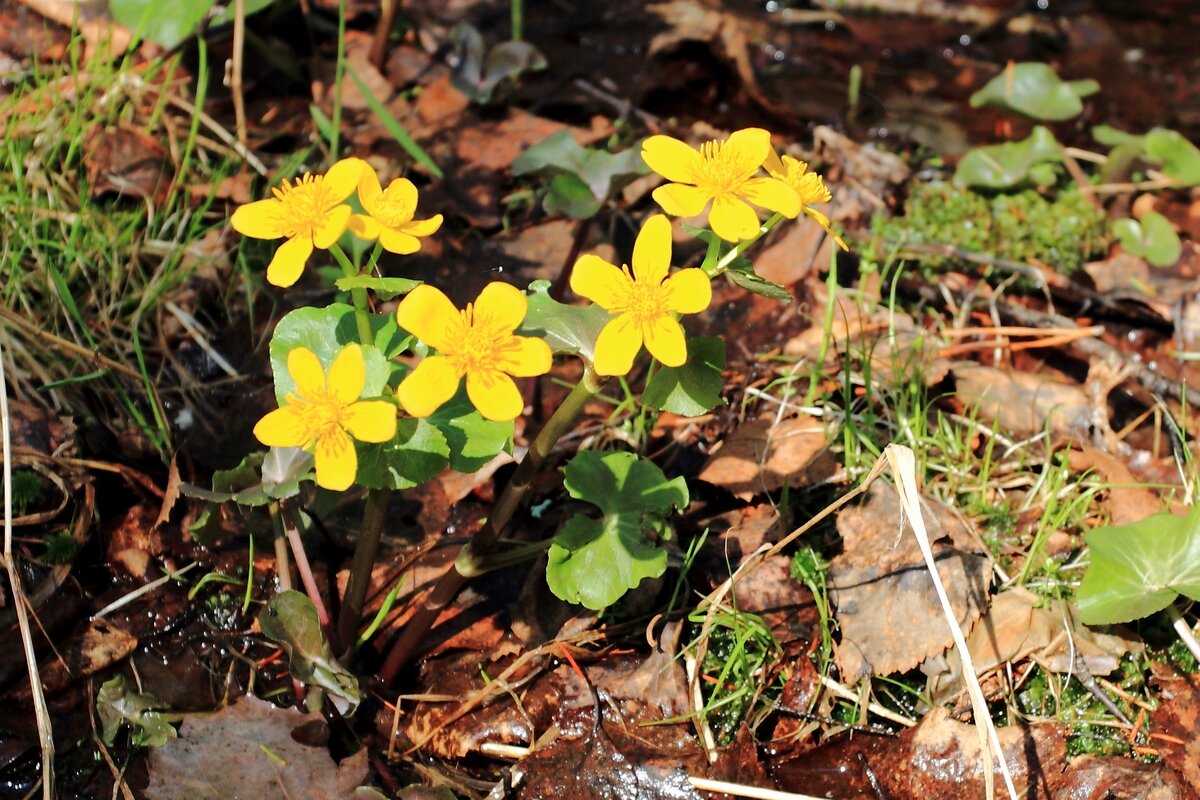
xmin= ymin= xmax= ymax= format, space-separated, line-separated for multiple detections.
xmin=829 ymin=481 xmax=991 ymax=684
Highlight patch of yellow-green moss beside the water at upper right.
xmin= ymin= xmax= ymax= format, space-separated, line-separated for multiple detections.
xmin=872 ymin=182 xmax=1109 ymax=275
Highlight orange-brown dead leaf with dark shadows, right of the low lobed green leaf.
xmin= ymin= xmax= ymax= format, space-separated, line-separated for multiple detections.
xmin=698 ymin=417 xmax=838 ymax=500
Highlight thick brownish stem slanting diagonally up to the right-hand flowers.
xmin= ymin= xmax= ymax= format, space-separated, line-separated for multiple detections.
xmin=379 ymin=367 xmax=602 ymax=684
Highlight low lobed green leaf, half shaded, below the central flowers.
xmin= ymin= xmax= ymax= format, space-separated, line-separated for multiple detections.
xmin=546 ymin=450 xmax=688 ymax=610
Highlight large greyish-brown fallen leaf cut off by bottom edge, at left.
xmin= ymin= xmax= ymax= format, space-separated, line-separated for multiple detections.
xmin=145 ymin=696 xmax=367 ymax=800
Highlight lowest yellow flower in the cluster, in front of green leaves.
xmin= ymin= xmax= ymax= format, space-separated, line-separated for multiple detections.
xmin=254 ymin=344 xmax=396 ymax=492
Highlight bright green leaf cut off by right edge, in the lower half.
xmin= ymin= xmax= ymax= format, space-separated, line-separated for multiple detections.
xmin=1075 ymin=506 xmax=1200 ymax=625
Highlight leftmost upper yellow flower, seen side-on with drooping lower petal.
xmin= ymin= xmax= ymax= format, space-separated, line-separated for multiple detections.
xmin=229 ymin=158 xmax=367 ymax=287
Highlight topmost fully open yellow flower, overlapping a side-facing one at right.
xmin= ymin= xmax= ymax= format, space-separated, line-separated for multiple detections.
xmin=642 ymin=128 xmax=800 ymax=242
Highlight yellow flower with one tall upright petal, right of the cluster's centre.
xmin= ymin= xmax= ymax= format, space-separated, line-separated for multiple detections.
xmin=571 ymin=215 xmax=713 ymax=375
